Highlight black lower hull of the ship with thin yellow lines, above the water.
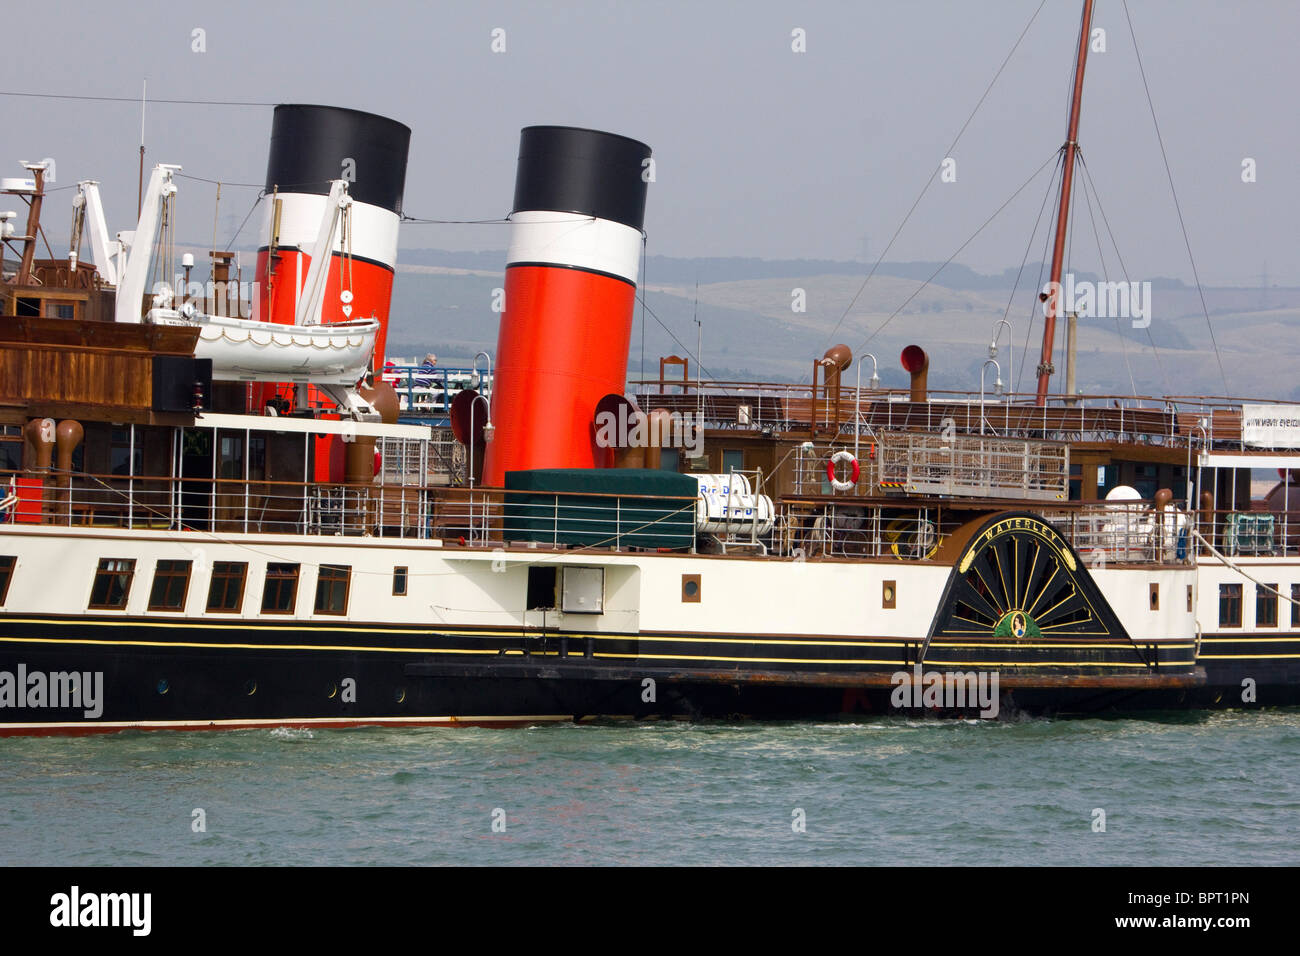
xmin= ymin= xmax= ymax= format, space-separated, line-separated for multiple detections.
xmin=0 ymin=619 xmax=1300 ymax=735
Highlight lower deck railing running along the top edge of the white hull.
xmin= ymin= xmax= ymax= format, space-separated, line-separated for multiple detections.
xmin=0 ymin=473 xmax=1196 ymax=564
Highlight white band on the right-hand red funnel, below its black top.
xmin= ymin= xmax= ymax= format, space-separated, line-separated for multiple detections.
xmin=506 ymin=212 xmax=641 ymax=283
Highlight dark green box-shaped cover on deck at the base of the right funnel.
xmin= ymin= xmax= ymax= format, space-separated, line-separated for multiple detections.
xmin=504 ymin=468 xmax=699 ymax=550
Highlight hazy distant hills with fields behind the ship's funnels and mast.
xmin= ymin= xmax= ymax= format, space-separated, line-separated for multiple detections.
xmin=389 ymin=250 xmax=1300 ymax=398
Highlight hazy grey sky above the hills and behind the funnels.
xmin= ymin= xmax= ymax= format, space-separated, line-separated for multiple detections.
xmin=0 ymin=0 xmax=1300 ymax=285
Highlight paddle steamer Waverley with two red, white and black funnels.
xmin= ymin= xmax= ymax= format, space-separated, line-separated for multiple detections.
xmin=0 ymin=1 xmax=1300 ymax=734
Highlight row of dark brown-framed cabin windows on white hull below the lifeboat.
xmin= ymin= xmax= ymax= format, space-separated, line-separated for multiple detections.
xmin=0 ymin=554 xmax=407 ymax=615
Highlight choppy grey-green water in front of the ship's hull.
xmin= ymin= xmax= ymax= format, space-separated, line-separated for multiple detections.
xmin=0 ymin=710 xmax=1300 ymax=865
